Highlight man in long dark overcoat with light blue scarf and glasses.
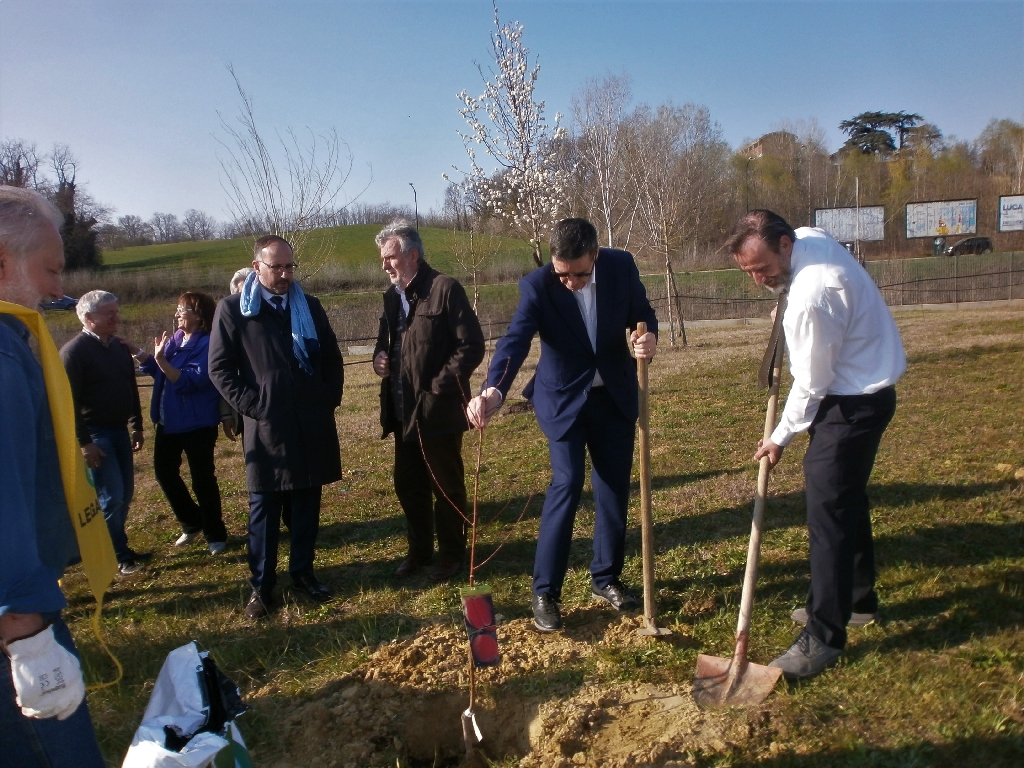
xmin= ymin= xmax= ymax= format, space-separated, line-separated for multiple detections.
xmin=210 ymin=234 xmax=344 ymax=618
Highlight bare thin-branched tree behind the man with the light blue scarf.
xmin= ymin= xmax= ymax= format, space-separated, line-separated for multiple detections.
xmin=218 ymin=67 xmax=370 ymax=272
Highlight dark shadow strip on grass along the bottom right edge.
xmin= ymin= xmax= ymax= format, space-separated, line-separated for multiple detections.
xmin=737 ymin=735 xmax=1024 ymax=768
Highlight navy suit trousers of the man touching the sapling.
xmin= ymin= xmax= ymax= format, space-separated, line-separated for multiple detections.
xmin=534 ymin=387 xmax=636 ymax=599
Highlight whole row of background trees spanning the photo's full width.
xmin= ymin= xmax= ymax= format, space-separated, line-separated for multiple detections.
xmin=0 ymin=1 xmax=1024 ymax=274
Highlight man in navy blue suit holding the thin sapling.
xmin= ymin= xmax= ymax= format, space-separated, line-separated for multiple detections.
xmin=467 ymin=218 xmax=657 ymax=632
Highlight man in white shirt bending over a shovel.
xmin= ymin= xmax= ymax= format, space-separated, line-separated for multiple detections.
xmin=726 ymin=210 xmax=906 ymax=680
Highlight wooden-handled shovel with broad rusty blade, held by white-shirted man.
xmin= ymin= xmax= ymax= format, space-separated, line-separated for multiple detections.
xmin=693 ymin=294 xmax=785 ymax=707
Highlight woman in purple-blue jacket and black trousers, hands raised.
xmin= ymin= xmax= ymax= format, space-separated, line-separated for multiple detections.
xmin=136 ymin=291 xmax=227 ymax=555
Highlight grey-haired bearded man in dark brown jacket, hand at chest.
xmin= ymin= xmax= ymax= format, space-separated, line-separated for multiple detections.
xmin=374 ymin=221 xmax=483 ymax=582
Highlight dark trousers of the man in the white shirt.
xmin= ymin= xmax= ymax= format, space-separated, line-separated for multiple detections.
xmin=804 ymin=387 xmax=896 ymax=649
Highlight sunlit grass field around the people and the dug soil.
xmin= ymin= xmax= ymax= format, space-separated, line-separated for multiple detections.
xmin=54 ymin=309 xmax=1024 ymax=768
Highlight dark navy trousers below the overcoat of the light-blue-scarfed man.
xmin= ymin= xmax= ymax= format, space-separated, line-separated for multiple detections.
xmin=249 ymin=485 xmax=324 ymax=593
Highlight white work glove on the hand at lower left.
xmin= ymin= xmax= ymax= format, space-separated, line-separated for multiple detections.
xmin=7 ymin=627 xmax=85 ymax=720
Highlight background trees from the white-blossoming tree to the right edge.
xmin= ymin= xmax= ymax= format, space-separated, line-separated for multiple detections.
xmin=442 ymin=7 xmax=1024 ymax=280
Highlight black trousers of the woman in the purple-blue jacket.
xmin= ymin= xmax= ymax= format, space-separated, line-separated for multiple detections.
xmin=153 ymin=424 xmax=227 ymax=544
